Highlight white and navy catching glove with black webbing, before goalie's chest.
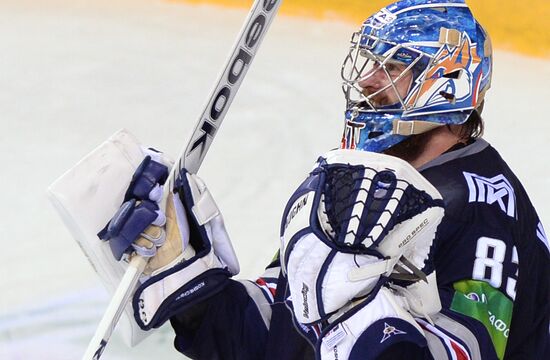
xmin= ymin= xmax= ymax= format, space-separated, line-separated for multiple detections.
xmin=280 ymin=150 xmax=444 ymax=324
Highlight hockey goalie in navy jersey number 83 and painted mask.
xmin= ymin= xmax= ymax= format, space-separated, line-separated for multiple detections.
xmin=49 ymin=0 xmax=550 ymax=360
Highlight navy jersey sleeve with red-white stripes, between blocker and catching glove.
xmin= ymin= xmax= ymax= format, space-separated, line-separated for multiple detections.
xmin=170 ymin=265 xmax=279 ymax=360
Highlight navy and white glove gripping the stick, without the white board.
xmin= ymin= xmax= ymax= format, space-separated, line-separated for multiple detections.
xmin=99 ymin=150 xmax=239 ymax=330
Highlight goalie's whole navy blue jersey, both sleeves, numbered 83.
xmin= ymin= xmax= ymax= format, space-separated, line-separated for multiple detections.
xmin=171 ymin=140 xmax=550 ymax=360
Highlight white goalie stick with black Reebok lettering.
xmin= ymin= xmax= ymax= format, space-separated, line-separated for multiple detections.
xmin=82 ymin=0 xmax=282 ymax=360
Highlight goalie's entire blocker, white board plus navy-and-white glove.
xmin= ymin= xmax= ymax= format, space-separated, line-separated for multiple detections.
xmin=48 ymin=129 xmax=239 ymax=338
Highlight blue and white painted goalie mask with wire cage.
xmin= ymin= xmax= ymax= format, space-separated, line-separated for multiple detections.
xmin=342 ymin=0 xmax=492 ymax=152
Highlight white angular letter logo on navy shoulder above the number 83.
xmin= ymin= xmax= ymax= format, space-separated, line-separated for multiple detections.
xmin=463 ymin=171 xmax=516 ymax=218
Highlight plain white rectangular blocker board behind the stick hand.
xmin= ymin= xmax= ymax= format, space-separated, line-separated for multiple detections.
xmin=48 ymin=129 xmax=150 ymax=346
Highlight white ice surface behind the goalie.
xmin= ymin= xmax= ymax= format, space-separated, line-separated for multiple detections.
xmin=0 ymin=0 xmax=550 ymax=360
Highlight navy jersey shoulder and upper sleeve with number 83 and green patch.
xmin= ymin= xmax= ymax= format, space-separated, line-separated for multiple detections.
xmin=420 ymin=140 xmax=550 ymax=359
